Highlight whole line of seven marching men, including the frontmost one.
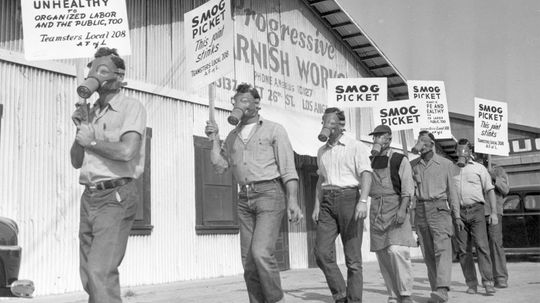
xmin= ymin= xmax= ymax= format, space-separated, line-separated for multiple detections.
xmin=70 ymin=48 xmax=508 ymax=303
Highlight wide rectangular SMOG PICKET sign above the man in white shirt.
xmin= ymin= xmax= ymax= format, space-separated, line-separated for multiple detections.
xmin=328 ymin=78 xmax=388 ymax=108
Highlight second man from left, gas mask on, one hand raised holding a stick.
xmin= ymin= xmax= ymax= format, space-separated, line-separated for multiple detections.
xmin=205 ymin=83 xmax=302 ymax=303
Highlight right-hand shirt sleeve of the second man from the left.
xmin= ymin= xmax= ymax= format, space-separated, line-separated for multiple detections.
xmin=273 ymin=125 xmax=298 ymax=183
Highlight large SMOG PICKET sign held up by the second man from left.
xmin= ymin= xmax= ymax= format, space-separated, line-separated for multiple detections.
xmin=184 ymin=0 xmax=234 ymax=88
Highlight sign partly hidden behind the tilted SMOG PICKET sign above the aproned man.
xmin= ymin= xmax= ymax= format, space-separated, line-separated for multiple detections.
xmin=407 ymin=80 xmax=452 ymax=138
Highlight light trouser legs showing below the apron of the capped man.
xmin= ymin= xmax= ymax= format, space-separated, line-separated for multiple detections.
xmin=375 ymin=245 xmax=413 ymax=301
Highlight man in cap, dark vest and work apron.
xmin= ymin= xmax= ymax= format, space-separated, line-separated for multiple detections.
xmin=369 ymin=125 xmax=416 ymax=303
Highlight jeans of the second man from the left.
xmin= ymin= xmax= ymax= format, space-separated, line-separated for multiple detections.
xmin=238 ymin=181 xmax=286 ymax=303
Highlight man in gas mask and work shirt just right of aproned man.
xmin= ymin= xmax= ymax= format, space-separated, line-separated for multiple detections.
xmin=411 ymin=131 xmax=463 ymax=302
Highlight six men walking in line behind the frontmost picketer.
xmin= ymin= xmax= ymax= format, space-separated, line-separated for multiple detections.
xmin=205 ymin=84 xmax=508 ymax=303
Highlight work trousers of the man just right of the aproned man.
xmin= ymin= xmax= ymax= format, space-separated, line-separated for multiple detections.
xmin=415 ymin=200 xmax=454 ymax=291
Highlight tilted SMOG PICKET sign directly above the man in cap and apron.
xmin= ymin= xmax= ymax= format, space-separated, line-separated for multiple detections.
xmin=373 ymin=100 xmax=427 ymax=131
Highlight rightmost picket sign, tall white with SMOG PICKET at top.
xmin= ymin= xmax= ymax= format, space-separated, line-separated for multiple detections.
xmin=474 ymin=98 xmax=508 ymax=156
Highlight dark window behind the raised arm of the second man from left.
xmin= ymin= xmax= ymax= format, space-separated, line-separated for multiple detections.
xmin=193 ymin=136 xmax=239 ymax=235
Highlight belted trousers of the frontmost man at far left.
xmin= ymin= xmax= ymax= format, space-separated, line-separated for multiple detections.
xmin=79 ymin=181 xmax=138 ymax=303
